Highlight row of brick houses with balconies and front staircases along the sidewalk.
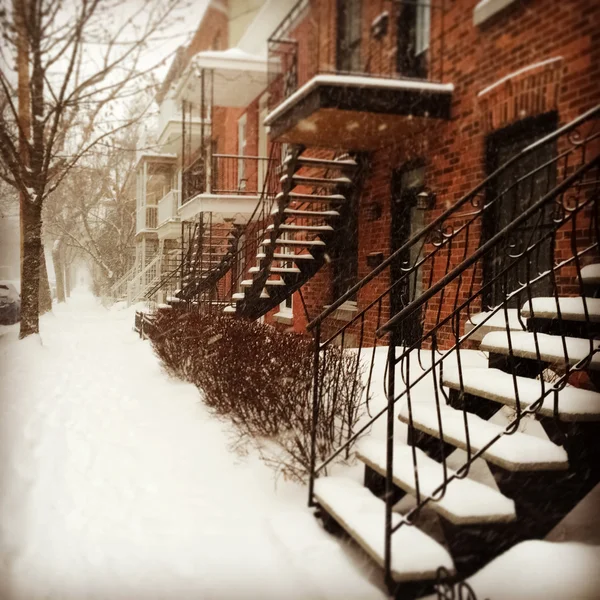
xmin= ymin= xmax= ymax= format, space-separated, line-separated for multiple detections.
xmin=128 ymin=0 xmax=600 ymax=598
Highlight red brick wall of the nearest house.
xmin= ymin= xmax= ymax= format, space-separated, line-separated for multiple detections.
xmin=266 ymin=0 xmax=600 ymax=342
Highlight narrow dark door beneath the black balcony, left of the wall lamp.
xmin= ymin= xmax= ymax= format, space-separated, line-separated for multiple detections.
xmin=390 ymin=166 xmax=425 ymax=346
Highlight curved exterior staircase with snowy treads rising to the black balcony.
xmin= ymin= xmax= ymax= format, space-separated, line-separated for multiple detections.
xmin=225 ymin=146 xmax=360 ymax=319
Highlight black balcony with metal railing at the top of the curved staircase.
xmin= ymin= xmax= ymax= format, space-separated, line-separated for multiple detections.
xmin=265 ymin=0 xmax=454 ymax=150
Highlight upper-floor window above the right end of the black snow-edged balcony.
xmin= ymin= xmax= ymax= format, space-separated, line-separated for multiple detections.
xmin=396 ymin=0 xmax=431 ymax=78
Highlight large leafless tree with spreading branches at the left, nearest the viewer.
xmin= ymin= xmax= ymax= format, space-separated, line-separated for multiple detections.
xmin=0 ymin=0 xmax=181 ymax=337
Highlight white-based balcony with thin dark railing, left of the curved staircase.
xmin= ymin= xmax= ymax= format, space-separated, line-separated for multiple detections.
xmin=178 ymin=153 xmax=270 ymax=220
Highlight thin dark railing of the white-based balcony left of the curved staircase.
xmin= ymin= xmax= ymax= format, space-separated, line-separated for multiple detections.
xmin=181 ymin=154 xmax=270 ymax=204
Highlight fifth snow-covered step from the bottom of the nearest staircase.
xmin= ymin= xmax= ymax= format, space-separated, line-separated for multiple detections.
xmin=481 ymin=331 xmax=600 ymax=370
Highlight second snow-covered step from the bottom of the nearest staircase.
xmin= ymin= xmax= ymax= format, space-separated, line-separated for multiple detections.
xmin=357 ymin=440 xmax=516 ymax=525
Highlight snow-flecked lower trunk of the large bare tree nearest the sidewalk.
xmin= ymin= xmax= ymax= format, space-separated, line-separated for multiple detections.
xmin=19 ymin=201 xmax=43 ymax=338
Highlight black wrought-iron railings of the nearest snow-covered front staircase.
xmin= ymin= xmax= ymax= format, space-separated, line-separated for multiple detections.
xmin=308 ymin=106 xmax=600 ymax=581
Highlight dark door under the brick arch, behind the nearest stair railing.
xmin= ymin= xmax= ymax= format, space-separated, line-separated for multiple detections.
xmin=484 ymin=117 xmax=556 ymax=308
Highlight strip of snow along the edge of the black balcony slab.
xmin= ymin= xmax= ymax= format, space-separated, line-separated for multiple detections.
xmin=264 ymin=75 xmax=454 ymax=125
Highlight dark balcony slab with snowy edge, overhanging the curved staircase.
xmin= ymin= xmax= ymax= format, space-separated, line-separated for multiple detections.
xmin=265 ymin=75 xmax=454 ymax=150
